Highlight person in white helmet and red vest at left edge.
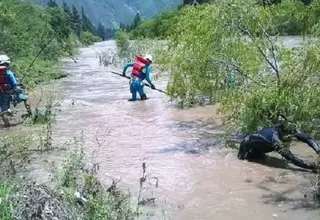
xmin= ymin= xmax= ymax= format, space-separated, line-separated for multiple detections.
xmin=0 ymin=54 xmax=31 ymax=127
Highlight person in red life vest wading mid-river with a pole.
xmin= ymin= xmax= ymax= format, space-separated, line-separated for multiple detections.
xmin=122 ymin=54 xmax=156 ymax=101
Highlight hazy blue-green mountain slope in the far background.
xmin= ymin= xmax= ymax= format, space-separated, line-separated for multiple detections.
xmin=33 ymin=0 xmax=183 ymax=27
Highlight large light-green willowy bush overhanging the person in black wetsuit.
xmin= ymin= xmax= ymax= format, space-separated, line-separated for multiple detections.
xmin=154 ymin=0 xmax=320 ymax=138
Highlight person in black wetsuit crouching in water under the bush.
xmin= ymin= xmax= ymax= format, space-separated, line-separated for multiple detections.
xmin=238 ymin=117 xmax=320 ymax=172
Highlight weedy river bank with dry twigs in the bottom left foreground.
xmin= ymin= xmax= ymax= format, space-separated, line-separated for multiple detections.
xmin=0 ymin=42 xmax=135 ymax=220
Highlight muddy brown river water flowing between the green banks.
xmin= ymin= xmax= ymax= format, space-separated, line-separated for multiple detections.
xmin=46 ymin=41 xmax=320 ymax=220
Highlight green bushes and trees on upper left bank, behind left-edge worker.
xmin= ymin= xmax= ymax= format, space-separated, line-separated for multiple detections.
xmin=0 ymin=0 xmax=98 ymax=87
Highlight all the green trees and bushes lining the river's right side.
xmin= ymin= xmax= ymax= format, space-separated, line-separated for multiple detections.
xmin=112 ymin=0 xmax=320 ymax=201
